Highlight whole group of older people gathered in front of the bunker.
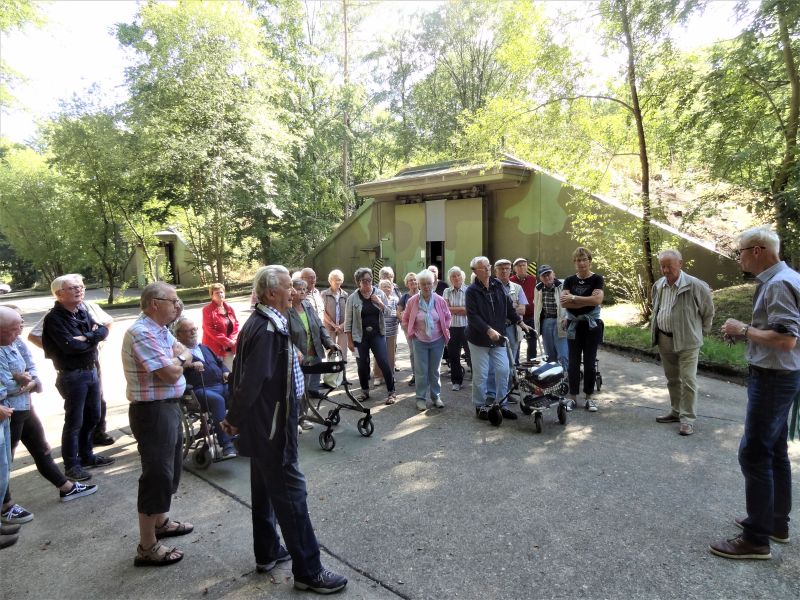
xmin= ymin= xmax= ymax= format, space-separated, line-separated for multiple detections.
xmin=0 ymin=228 xmax=800 ymax=580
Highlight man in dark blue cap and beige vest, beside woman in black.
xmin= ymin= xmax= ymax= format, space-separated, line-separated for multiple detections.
xmin=533 ymin=265 xmax=569 ymax=371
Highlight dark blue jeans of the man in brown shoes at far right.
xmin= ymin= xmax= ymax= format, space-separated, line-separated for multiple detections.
xmin=739 ymin=367 xmax=800 ymax=546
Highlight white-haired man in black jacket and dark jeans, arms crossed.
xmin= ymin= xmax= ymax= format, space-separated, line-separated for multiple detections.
xmin=42 ymin=274 xmax=114 ymax=481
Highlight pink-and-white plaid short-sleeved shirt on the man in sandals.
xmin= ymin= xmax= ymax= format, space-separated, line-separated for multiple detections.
xmin=122 ymin=313 xmax=186 ymax=402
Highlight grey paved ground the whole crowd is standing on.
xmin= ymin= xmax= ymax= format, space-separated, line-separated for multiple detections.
xmin=0 ymin=290 xmax=800 ymax=599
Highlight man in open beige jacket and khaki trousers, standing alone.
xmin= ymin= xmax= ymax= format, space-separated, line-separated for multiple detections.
xmin=650 ymin=250 xmax=714 ymax=435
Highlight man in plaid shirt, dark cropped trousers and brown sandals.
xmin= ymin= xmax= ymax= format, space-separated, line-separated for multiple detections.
xmin=122 ymin=281 xmax=194 ymax=567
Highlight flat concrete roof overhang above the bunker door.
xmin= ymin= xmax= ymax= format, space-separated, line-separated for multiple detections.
xmin=355 ymin=155 xmax=535 ymax=202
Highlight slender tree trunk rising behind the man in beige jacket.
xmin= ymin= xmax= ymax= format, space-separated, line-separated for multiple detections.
xmin=618 ymin=0 xmax=655 ymax=319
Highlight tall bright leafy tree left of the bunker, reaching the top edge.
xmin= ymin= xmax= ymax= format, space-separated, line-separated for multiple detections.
xmin=117 ymin=0 xmax=295 ymax=281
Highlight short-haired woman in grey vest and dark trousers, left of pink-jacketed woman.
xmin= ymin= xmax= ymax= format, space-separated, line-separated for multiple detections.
xmin=344 ymin=267 xmax=397 ymax=404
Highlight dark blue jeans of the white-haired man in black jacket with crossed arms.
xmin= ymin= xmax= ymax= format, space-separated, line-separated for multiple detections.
xmin=56 ymin=367 xmax=100 ymax=470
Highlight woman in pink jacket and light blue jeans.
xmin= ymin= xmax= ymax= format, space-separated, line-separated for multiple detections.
xmin=403 ymin=269 xmax=452 ymax=411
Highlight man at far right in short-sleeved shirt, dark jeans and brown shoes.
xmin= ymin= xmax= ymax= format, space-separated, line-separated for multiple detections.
xmin=710 ymin=227 xmax=800 ymax=559
